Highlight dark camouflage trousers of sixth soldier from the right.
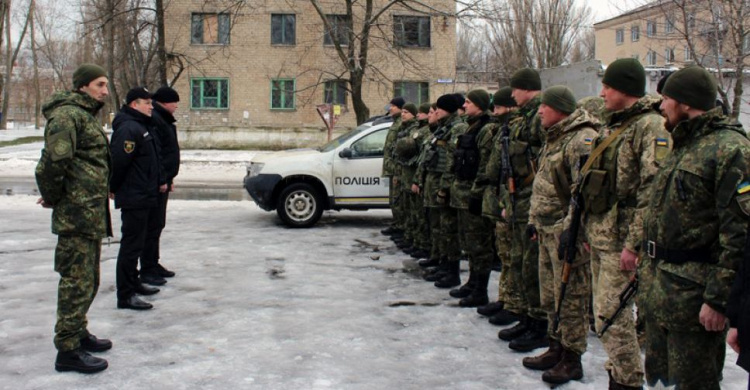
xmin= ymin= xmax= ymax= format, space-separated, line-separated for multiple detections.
xmin=458 ymin=209 xmax=495 ymax=273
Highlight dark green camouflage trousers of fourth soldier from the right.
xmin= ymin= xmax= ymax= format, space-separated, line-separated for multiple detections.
xmin=503 ymin=221 xmax=547 ymax=320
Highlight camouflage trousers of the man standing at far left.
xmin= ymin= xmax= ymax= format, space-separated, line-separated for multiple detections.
xmin=54 ymin=236 xmax=102 ymax=351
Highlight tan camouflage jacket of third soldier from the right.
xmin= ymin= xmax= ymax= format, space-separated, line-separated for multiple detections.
xmin=529 ymin=109 xmax=597 ymax=226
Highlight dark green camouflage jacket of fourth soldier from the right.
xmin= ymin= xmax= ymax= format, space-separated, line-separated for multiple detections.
xmin=503 ymin=95 xmax=544 ymax=224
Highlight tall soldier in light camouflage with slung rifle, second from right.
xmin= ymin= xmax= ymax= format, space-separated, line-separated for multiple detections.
xmin=576 ymin=58 xmax=671 ymax=389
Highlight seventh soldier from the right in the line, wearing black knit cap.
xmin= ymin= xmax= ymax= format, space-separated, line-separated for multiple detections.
xmin=423 ymin=95 xmax=466 ymax=288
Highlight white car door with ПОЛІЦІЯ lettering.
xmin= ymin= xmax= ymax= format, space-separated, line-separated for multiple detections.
xmin=333 ymin=126 xmax=388 ymax=208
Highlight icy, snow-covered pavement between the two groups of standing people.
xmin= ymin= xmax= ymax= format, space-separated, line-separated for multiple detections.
xmin=0 ymin=196 xmax=747 ymax=390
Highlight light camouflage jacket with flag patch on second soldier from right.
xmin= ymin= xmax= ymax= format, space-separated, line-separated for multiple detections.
xmin=582 ymin=96 xmax=672 ymax=252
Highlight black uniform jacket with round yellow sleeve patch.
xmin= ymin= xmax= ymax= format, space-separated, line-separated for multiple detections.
xmin=109 ymin=106 xmax=160 ymax=209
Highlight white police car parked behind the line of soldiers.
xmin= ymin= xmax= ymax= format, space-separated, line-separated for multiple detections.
xmin=244 ymin=118 xmax=392 ymax=227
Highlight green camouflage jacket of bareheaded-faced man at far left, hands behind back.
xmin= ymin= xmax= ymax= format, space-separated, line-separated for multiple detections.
xmin=36 ymin=91 xmax=112 ymax=239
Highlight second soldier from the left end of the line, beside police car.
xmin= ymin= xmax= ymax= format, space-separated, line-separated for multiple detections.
xmin=392 ymin=103 xmax=419 ymax=254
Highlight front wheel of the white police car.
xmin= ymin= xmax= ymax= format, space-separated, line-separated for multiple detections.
xmin=276 ymin=183 xmax=323 ymax=228
